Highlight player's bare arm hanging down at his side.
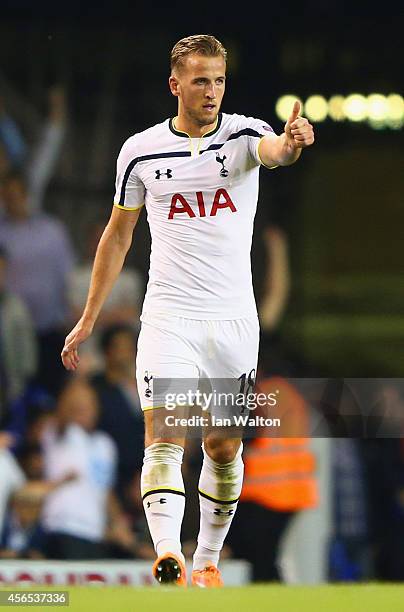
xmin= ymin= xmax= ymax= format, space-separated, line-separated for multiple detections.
xmin=62 ymin=206 xmax=141 ymax=370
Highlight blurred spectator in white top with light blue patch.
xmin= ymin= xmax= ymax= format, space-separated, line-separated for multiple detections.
xmin=39 ymin=380 xmax=133 ymax=559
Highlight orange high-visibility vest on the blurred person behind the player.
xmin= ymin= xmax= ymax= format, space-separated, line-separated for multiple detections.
xmin=240 ymin=377 xmax=318 ymax=512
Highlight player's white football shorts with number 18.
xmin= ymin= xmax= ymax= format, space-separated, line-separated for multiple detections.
xmin=136 ymin=314 xmax=259 ymax=413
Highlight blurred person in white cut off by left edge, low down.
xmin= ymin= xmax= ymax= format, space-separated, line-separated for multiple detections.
xmin=0 ymin=431 xmax=25 ymax=533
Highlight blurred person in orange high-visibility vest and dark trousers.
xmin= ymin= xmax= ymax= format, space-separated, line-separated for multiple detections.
xmin=227 ymin=377 xmax=318 ymax=582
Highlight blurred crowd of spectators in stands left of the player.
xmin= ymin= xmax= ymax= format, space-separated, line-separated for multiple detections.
xmin=0 ymin=87 xmax=153 ymax=558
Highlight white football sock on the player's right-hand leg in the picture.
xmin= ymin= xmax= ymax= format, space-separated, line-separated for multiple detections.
xmin=193 ymin=444 xmax=244 ymax=570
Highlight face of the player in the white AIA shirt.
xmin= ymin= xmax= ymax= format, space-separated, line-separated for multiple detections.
xmin=170 ymin=54 xmax=226 ymax=126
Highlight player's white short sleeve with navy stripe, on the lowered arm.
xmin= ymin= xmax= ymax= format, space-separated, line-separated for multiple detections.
xmin=114 ymin=136 xmax=145 ymax=210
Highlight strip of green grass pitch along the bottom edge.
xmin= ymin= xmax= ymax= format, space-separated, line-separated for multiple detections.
xmin=3 ymin=584 xmax=404 ymax=612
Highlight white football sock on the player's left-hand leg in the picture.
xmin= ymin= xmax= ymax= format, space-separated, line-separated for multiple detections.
xmin=140 ymin=443 xmax=185 ymax=562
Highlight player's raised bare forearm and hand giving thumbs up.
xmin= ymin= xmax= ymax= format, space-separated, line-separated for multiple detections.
xmin=258 ymin=100 xmax=314 ymax=168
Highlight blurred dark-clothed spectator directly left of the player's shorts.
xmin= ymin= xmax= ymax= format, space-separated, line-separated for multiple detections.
xmin=91 ymin=324 xmax=144 ymax=503
